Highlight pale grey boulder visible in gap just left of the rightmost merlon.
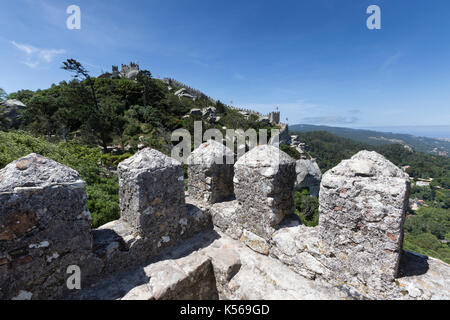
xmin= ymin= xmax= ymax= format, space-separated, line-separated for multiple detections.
xmin=295 ymin=159 xmax=322 ymax=197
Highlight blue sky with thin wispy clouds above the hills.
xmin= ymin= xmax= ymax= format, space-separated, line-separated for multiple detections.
xmin=0 ymin=0 xmax=450 ymax=132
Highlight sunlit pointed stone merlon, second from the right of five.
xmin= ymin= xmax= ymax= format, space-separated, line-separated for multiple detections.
xmin=234 ymin=145 xmax=296 ymax=239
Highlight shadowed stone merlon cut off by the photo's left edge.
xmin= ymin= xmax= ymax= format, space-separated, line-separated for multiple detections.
xmin=0 ymin=154 xmax=101 ymax=299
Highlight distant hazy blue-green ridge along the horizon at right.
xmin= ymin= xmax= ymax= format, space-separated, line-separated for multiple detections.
xmin=289 ymin=124 xmax=450 ymax=157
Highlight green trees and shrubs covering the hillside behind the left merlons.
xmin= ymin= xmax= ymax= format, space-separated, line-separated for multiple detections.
xmin=0 ymin=60 xmax=271 ymax=228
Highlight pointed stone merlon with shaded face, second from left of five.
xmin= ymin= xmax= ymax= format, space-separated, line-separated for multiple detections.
xmin=118 ymin=148 xmax=186 ymax=244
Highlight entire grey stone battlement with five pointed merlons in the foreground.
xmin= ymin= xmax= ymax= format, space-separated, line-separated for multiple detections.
xmin=0 ymin=146 xmax=450 ymax=299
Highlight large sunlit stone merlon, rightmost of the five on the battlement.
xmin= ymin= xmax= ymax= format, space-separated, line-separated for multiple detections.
xmin=319 ymin=151 xmax=410 ymax=293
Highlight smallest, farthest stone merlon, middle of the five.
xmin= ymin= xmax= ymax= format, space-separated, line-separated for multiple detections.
xmin=188 ymin=140 xmax=234 ymax=204
